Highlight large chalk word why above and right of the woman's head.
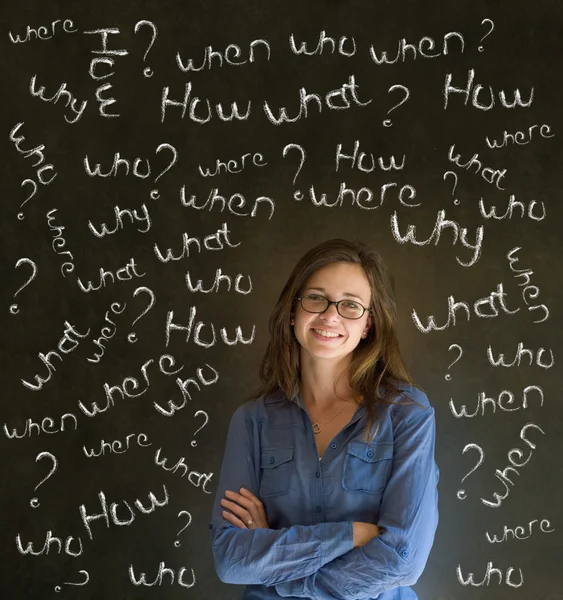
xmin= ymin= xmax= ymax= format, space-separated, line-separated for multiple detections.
xmin=391 ymin=210 xmax=484 ymax=267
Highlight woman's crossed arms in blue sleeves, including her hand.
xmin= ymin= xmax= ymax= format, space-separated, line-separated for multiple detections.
xmin=212 ymin=409 xmax=438 ymax=600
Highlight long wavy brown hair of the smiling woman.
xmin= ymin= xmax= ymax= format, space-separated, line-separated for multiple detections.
xmin=248 ymin=239 xmax=424 ymax=441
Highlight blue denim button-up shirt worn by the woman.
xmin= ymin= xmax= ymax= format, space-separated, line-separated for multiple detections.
xmin=209 ymin=384 xmax=439 ymax=600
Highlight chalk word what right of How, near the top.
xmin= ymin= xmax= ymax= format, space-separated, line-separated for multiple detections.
xmin=263 ymin=75 xmax=371 ymax=125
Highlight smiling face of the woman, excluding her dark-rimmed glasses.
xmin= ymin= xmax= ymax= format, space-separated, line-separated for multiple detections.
xmin=293 ymin=262 xmax=372 ymax=360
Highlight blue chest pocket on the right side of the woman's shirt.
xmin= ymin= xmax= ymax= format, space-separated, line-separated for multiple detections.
xmin=342 ymin=442 xmax=393 ymax=494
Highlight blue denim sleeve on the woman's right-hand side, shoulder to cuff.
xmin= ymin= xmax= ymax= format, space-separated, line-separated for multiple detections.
xmin=276 ymin=405 xmax=439 ymax=600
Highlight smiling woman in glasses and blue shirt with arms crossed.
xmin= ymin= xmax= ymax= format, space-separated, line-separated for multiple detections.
xmin=210 ymin=239 xmax=439 ymax=600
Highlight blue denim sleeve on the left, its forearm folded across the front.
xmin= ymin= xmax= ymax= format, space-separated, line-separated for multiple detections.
xmin=209 ymin=405 xmax=354 ymax=586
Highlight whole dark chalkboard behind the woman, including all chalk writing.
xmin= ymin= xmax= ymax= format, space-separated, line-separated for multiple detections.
xmin=0 ymin=0 xmax=563 ymax=600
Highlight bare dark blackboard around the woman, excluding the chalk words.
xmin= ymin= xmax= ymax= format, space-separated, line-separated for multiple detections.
xmin=0 ymin=1 xmax=563 ymax=600
